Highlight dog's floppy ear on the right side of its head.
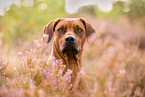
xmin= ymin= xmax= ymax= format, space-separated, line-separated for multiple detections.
xmin=80 ymin=18 xmax=95 ymax=37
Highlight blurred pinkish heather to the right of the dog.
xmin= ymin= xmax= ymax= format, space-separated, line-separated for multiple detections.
xmin=84 ymin=36 xmax=145 ymax=97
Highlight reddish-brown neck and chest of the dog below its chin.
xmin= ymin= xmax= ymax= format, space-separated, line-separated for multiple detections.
xmin=52 ymin=41 xmax=82 ymax=82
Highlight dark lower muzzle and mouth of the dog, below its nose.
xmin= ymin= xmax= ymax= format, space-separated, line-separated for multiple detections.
xmin=61 ymin=44 xmax=81 ymax=54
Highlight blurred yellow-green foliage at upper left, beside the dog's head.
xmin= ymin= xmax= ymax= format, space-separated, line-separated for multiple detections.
xmin=0 ymin=0 xmax=66 ymax=43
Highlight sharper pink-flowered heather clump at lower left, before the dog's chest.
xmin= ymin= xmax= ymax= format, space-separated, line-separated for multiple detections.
xmin=1 ymin=40 xmax=75 ymax=97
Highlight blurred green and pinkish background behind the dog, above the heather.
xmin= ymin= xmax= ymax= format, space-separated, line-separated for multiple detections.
xmin=0 ymin=0 xmax=145 ymax=74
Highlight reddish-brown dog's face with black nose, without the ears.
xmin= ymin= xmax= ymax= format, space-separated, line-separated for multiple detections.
xmin=54 ymin=19 xmax=86 ymax=54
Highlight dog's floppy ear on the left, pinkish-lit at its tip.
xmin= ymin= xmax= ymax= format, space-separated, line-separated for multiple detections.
xmin=43 ymin=18 xmax=61 ymax=43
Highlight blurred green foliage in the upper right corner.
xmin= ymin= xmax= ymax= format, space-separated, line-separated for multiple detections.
xmin=96 ymin=0 xmax=145 ymax=21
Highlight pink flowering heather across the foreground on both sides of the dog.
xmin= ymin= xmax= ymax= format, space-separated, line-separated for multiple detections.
xmin=0 ymin=37 xmax=145 ymax=97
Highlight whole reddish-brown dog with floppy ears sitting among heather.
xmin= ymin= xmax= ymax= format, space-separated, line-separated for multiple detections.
xmin=43 ymin=18 xmax=95 ymax=90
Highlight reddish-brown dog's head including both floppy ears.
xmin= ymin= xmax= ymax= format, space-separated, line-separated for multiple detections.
xmin=43 ymin=18 xmax=95 ymax=54
